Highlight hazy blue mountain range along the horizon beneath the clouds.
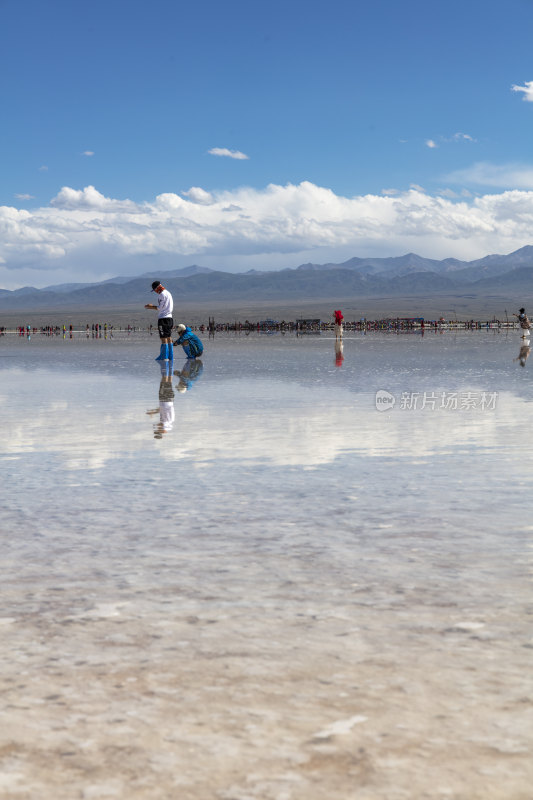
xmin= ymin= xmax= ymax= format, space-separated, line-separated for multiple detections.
xmin=0 ymin=245 xmax=533 ymax=311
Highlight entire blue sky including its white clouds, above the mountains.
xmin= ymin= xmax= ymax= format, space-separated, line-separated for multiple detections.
xmin=0 ymin=0 xmax=533 ymax=288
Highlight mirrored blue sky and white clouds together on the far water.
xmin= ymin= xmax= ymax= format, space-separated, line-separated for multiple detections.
xmin=0 ymin=333 xmax=533 ymax=466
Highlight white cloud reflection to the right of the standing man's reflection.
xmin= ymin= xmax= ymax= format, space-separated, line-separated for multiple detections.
xmin=164 ymin=381 xmax=524 ymax=467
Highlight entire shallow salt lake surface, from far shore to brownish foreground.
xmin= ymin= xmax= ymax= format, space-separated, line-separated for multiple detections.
xmin=0 ymin=331 xmax=533 ymax=800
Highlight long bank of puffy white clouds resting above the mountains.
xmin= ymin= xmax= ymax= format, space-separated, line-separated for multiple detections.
xmin=0 ymin=183 xmax=533 ymax=289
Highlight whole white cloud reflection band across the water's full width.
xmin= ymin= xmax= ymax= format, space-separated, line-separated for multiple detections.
xmin=0 ymin=370 xmax=530 ymax=471
